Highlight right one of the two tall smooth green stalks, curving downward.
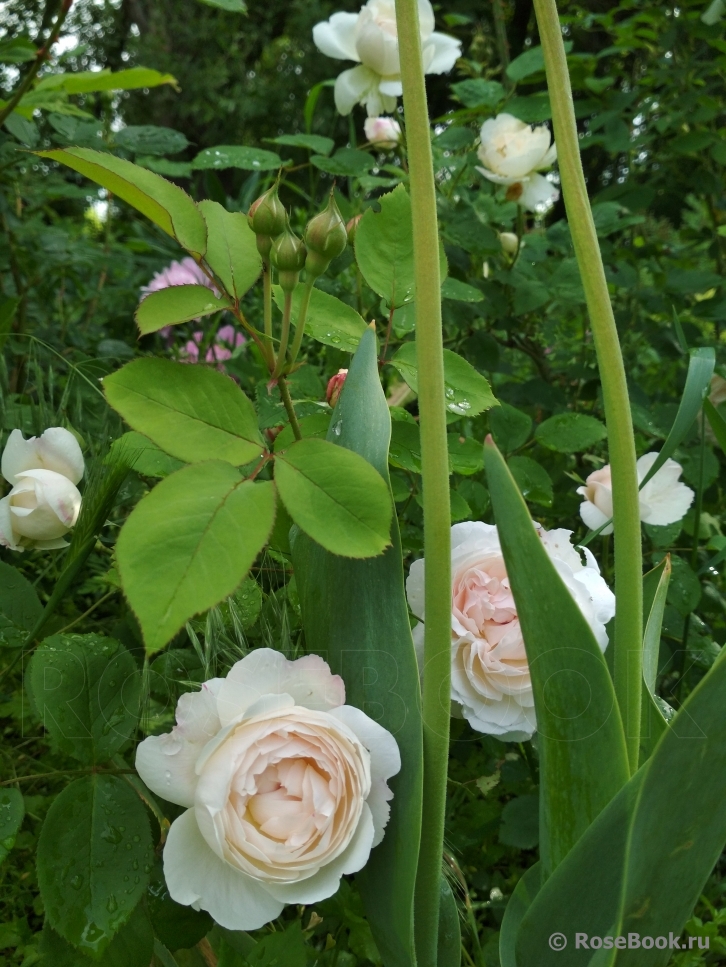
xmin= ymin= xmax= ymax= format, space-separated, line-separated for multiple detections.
xmin=534 ymin=0 xmax=643 ymax=772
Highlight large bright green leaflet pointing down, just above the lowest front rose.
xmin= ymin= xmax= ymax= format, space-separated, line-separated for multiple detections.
xmin=116 ymin=464 xmax=275 ymax=654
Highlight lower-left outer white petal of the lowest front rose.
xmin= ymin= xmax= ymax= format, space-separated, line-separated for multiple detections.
xmin=164 ymin=809 xmax=284 ymax=930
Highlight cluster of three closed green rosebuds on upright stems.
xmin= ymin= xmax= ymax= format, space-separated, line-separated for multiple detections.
xmin=247 ymin=185 xmax=348 ymax=292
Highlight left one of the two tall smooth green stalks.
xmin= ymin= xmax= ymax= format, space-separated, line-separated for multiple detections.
xmin=396 ymin=0 xmax=451 ymax=967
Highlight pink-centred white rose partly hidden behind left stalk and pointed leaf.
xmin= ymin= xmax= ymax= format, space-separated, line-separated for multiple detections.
xmin=406 ymin=521 xmax=615 ymax=742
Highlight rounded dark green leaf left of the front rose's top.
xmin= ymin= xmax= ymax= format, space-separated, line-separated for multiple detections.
xmin=27 ymin=634 xmax=141 ymax=765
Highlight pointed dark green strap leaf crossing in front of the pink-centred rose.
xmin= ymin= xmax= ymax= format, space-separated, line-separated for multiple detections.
xmin=486 ymin=445 xmax=628 ymax=878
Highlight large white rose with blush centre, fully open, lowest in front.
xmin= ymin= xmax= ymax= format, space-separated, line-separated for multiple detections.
xmin=136 ymin=648 xmax=401 ymax=930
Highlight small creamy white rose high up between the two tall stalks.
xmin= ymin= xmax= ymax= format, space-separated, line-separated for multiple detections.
xmin=477 ymin=114 xmax=560 ymax=211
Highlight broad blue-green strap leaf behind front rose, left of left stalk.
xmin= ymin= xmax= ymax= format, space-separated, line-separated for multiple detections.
xmin=293 ymin=330 xmax=422 ymax=967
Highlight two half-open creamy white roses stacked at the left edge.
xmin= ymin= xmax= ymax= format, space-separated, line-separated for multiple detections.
xmin=0 ymin=426 xmax=84 ymax=551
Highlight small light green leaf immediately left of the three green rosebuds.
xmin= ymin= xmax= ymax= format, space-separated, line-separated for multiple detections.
xmin=199 ymin=201 xmax=262 ymax=300
